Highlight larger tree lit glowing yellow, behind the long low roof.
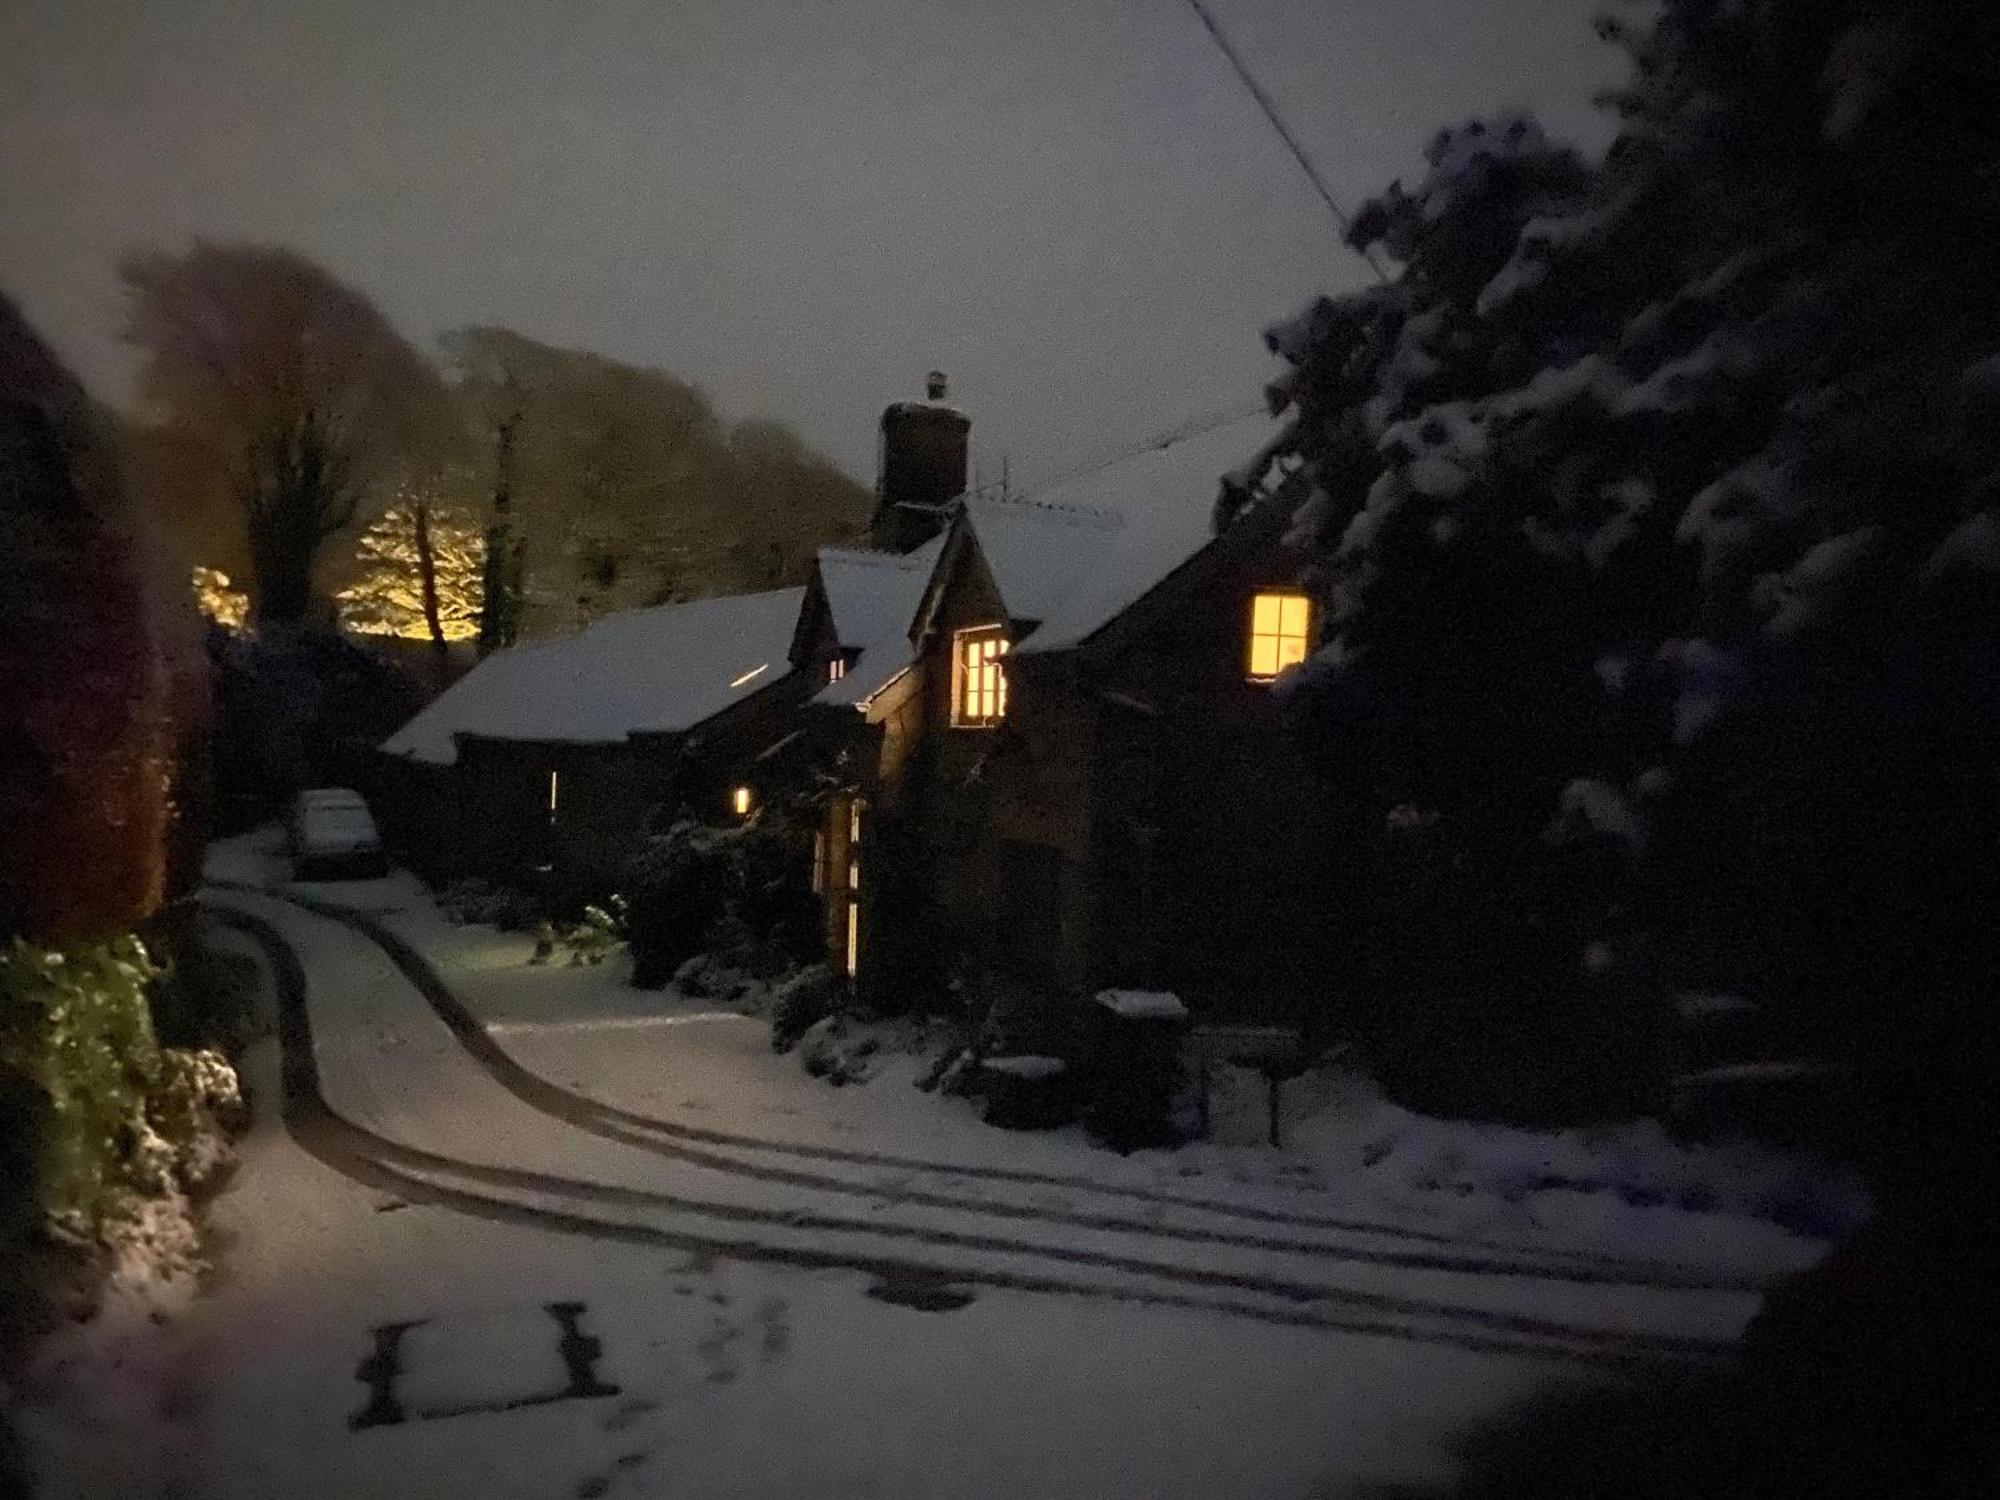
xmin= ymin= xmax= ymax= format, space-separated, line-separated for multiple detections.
xmin=334 ymin=486 xmax=486 ymax=652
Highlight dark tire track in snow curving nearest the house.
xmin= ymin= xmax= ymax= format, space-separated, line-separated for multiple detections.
xmin=250 ymin=882 xmax=1764 ymax=1294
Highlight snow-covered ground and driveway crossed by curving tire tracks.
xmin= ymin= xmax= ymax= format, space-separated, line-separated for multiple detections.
xmin=11 ymin=840 xmax=1856 ymax=1496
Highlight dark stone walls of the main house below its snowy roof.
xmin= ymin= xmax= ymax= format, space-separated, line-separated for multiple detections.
xmin=780 ymin=506 xmax=1342 ymax=1024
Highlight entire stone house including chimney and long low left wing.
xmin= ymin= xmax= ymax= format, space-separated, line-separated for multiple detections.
xmin=384 ymin=380 xmax=1342 ymax=1020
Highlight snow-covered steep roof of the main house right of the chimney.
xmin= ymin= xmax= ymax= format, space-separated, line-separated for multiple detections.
xmin=1008 ymin=412 xmax=1284 ymax=652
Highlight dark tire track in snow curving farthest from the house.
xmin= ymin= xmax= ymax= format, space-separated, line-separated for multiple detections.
xmin=212 ymin=892 xmax=1752 ymax=1364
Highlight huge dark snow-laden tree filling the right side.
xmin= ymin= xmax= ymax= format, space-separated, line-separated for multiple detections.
xmin=1222 ymin=0 xmax=2000 ymax=1142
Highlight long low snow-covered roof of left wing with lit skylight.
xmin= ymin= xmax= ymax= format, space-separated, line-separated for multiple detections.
xmin=382 ymin=588 xmax=806 ymax=766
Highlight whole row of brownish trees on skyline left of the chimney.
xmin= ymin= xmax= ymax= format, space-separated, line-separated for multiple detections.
xmin=122 ymin=242 xmax=868 ymax=650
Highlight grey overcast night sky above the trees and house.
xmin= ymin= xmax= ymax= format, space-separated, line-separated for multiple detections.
xmin=0 ymin=0 xmax=1618 ymax=490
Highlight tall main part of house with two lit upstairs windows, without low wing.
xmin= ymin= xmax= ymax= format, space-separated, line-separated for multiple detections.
xmin=776 ymin=384 xmax=1338 ymax=1018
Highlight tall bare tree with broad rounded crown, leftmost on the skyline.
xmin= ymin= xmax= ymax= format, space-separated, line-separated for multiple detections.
xmin=120 ymin=242 xmax=452 ymax=622
